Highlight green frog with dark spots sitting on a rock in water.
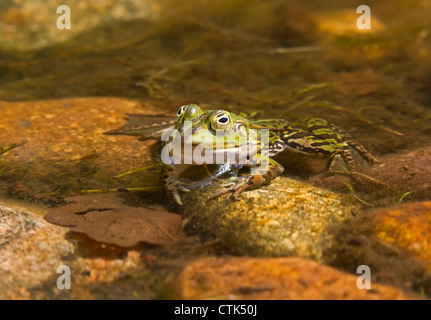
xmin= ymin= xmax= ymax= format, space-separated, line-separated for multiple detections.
xmin=107 ymin=104 xmax=377 ymax=205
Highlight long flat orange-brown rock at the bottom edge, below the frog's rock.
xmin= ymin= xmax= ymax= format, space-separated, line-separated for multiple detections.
xmin=178 ymin=257 xmax=407 ymax=300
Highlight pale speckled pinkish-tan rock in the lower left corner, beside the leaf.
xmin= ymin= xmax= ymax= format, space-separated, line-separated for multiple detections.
xmin=0 ymin=204 xmax=74 ymax=299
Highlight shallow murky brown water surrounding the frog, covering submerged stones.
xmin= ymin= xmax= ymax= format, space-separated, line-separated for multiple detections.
xmin=0 ymin=0 xmax=431 ymax=298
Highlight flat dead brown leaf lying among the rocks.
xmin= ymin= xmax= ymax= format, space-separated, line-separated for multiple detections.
xmin=45 ymin=193 xmax=186 ymax=247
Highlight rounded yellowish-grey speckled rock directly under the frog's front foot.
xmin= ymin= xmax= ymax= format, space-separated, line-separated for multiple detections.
xmin=184 ymin=177 xmax=357 ymax=259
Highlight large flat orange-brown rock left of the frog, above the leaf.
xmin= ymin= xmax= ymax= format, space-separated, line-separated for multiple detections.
xmin=0 ymin=98 xmax=165 ymax=201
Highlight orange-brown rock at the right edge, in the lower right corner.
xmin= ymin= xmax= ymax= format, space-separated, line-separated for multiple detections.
xmin=323 ymin=201 xmax=431 ymax=294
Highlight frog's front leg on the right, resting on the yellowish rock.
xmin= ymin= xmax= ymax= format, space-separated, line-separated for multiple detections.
xmin=210 ymin=156 xmax=284 ymax=200
